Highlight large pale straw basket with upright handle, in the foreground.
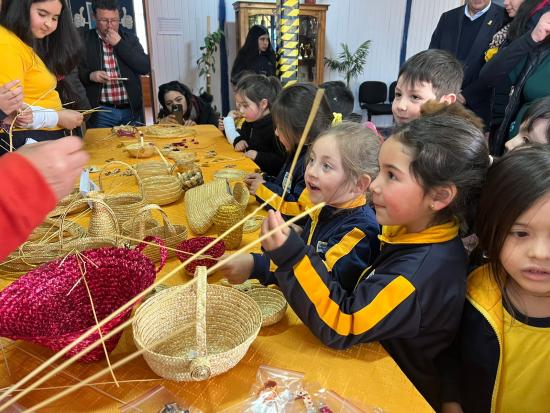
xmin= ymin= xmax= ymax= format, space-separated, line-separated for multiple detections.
xmin=132 ymin=267 xmax=262 ymax=381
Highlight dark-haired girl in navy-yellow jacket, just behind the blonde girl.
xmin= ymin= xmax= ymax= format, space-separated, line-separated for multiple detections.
xmin=245 ymin=83 xmax=333 ymax=217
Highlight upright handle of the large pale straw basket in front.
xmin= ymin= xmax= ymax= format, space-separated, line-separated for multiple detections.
xmin=189 ymin=267 xmax=212 ymax=381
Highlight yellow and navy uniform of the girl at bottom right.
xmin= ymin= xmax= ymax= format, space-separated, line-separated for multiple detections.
xmin=442 ymin=265 xmax=550 ymax=413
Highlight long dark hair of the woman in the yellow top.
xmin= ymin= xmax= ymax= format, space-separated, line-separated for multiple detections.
xmin=0 ymin=0 xmax=82 ymax=76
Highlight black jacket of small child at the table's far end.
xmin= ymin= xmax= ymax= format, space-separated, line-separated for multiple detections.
xmin=233 ymin=114 xmax=286 ymax=176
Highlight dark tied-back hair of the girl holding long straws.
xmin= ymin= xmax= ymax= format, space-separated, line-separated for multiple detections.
xmin=391 ymin=114 xmax=489 ymax=231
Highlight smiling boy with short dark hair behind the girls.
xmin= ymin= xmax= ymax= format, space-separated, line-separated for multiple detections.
xmin=392 ymin=49 xmax=464 ymax=125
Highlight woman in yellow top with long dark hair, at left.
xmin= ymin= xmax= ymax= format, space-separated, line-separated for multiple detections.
xmin=0 ymin=0 xmax=82 ymax=153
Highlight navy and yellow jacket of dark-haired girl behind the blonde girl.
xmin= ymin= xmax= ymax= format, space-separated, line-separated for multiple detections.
xmin=256 ymin=146 xmax=313 ymax=220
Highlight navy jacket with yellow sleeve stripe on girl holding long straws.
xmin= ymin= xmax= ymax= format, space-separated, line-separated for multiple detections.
xmin=266 ymin=222 xmax=467 ymax=409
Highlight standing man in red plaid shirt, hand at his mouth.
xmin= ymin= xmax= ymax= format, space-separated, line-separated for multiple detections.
xmin=79 ymin=0 xmax=150 ymax=128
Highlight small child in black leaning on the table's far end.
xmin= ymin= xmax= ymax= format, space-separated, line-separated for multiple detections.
xmin=232 ymin=75 xmax=285 ymax=175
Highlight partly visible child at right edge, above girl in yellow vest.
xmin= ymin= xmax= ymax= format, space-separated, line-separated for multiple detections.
xmin=504 ymin=96 xmax=550 ymax=151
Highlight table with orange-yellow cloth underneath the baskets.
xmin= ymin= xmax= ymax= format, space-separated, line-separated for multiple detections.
xmin=0 ymin=126 xmax=433 ymax=413
